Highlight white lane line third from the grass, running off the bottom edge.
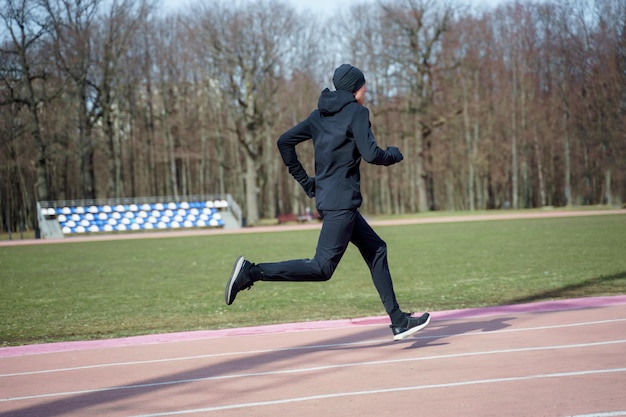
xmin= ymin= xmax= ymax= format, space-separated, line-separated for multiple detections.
xmin=129 ymin=368 xmax=626 ymax=417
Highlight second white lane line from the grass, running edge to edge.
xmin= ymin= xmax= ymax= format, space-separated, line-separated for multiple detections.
xmin=0 ymin=339 xmax=626 ymax=403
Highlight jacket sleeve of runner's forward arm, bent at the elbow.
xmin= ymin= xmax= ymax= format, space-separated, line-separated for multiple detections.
xmin=352 ymin=106 xmax=403 ymax=166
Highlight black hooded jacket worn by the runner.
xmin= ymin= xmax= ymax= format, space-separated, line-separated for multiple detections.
xmin=277 ymin=89 xmax=402 ymax=211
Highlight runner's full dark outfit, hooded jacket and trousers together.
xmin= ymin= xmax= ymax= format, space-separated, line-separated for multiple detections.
xmin=256 ymin=89 xmax=406 ymax=324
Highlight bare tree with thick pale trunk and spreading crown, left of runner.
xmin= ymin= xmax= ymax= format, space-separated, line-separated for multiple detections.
xmin=191 ymin=1 xmax=297 ymax=224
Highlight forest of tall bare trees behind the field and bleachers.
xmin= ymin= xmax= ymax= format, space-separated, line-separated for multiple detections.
xmin=0 ymin=0 xmax=626 ymax=231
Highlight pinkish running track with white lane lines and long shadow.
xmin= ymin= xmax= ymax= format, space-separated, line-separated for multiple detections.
xmin=0 ymin=296 xmax=626 ymax=417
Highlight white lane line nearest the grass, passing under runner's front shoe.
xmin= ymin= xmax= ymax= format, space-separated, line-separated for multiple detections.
xmin=0 ymin=318 xmax=626 ymax=378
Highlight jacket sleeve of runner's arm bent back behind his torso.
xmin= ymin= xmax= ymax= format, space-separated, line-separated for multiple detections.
xmin=276 ymin=119 xmax=315 ymax=198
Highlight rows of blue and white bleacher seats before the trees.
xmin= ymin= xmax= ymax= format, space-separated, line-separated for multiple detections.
xmin=41 ymin=200 xmax=228 ymax=235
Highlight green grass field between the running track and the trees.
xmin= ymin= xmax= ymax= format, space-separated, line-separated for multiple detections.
xmin=0 ymin=211 xmax=626 ymax=346
